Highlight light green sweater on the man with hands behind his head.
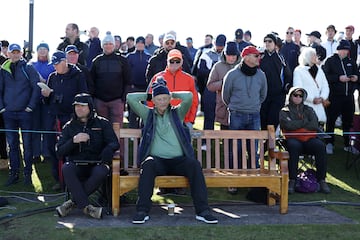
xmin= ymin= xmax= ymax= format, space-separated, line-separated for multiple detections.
xmin=127 ymin=92 xmax=192 ymax=159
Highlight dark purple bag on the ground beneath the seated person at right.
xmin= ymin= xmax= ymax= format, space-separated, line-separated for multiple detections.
xmin=295 ymin=169 xmax=319 ymax=193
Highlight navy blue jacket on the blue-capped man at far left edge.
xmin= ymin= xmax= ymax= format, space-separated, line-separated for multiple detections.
xmin=0 ymin=59 xmax=40 ymax=111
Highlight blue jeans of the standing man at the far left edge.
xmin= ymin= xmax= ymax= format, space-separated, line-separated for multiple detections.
xmin=3 ymin=111 xmax=33 ymax=175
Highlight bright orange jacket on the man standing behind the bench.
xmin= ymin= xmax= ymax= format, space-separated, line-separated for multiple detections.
xmin=148 ymin=68 xmax=199 ymax=123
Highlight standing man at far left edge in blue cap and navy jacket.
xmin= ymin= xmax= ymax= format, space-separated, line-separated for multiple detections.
xmin=0 ymin=43 xmax=40 ymax=186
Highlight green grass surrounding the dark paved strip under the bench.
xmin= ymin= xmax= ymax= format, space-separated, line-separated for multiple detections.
xmin=0 ymin=117 xmax=360 ymax=240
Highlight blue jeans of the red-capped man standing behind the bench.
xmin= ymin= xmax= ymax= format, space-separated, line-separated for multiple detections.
xmin=229 ymin=111 xmax=260 ymax=168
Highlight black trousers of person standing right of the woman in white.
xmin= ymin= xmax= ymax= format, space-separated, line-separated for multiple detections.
xmin=325 ymin=94 xmax=355 ymax=146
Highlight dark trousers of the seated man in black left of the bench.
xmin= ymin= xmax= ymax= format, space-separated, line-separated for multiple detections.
xmin=62 ymin=162 xmax=109 ymax=209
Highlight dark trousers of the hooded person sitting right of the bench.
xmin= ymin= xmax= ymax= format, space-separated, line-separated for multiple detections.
xmin=286 ymin=138 xmax=326 ymax=181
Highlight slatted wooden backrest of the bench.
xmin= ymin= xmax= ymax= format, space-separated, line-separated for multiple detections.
xmin=119 ymin=126 xmax=276 ymax=170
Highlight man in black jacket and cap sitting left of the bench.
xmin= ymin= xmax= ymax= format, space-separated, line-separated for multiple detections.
xmin=56 ymin=93 xmax=120 ymax=218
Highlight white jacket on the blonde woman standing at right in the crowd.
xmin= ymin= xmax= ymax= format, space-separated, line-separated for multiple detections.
xmin=293 ymin=66 xmax=329 ymax=122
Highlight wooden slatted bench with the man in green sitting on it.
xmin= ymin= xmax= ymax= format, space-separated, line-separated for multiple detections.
xmin=112 ymin=126 xmax=288 ymax=215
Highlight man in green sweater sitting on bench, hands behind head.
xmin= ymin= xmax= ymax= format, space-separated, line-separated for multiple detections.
xmin=127 ymin=77 xmax=218 ymax=224
